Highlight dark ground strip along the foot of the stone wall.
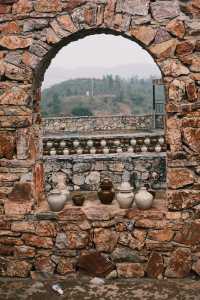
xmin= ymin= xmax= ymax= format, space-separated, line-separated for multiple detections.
xmin=0 ymin=277 xmax=200 ymax=300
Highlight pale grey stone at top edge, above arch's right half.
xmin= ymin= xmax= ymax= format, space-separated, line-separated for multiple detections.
xmin=116 ymin=0 xmax=150 ymax=16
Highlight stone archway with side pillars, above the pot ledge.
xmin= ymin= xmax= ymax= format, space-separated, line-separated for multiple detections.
xmin=0 ymin=0 xmax=200 ymax=278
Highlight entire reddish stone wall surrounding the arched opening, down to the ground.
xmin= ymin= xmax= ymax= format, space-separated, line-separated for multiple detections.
xmin=0 ymin=0 xmax=200 ymax=278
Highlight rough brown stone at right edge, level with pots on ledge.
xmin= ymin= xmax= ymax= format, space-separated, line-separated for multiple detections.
xmin=168 ymin=190 xmax=200 ymax=210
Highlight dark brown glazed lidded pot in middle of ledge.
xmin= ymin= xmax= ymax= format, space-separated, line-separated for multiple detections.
xmin=97 ymin=178 xmax=115 ymax=204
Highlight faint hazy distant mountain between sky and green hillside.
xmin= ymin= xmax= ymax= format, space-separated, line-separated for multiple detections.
xmin=43 ymin=63 xmax=161 ymax=89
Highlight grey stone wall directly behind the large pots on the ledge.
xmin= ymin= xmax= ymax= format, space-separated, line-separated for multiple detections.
xmin=44 ymin=153 xmax=166 ymax=192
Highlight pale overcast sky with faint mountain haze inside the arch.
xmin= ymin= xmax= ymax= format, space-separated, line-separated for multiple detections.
xmin=43 ymin=34 xmax=160 ymax=87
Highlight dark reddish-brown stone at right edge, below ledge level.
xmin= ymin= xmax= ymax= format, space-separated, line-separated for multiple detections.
xmin=174 ymin=221 xmax=200 ymax=246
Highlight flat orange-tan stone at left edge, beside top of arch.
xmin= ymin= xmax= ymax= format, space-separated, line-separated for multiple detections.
xmin=0 ymin=35 xmax=32 ymax=50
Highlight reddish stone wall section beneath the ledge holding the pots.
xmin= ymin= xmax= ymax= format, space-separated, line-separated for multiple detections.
xmin=0 ymin=205 xmax=200 ymax=279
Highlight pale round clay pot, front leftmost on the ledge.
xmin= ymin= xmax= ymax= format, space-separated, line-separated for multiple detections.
xmin=47 ymin=191 xmax=66 ymax=212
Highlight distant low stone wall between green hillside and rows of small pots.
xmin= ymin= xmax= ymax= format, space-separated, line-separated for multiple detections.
xmin=43 ymin=115 xmax=153 ymax=132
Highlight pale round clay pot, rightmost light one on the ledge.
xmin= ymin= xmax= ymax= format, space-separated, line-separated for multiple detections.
xmin=135 ymin=187 xmax=154 ymax=210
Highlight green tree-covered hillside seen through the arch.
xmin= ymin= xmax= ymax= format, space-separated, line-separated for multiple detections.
xmin=41 ymin=75 xmax=164 ymax=117
